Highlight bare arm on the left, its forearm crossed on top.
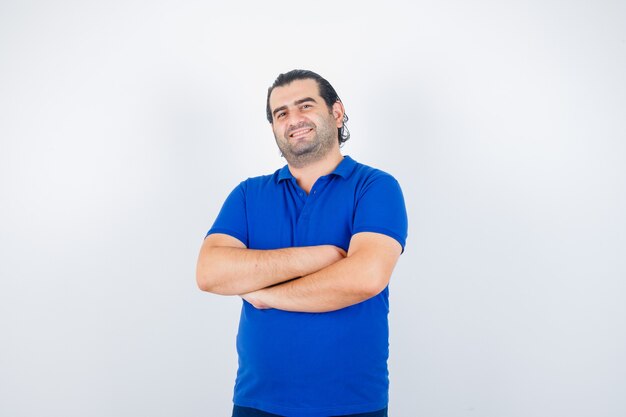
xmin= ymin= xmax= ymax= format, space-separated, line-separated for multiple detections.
xmin=196 ymin=245 xmax=345 ymax=295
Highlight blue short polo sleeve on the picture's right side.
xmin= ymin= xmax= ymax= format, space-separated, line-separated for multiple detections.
xmin=352 ymin=173 xmax=408 ymax=252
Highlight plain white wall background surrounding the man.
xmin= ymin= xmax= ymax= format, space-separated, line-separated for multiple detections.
xmin=0 ymin=0 xmax=626 ymax=417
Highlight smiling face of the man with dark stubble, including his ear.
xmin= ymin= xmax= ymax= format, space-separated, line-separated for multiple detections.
xmin=270 ymin=79 xmax=343 ymax=168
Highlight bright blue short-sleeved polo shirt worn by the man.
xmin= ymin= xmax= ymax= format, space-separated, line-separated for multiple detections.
xmin=207 ymin=156 xmax=407 ymax=417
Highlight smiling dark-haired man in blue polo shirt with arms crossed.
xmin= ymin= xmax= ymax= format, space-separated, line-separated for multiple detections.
xmin=197 ymin=70 xmax=407 ymax=417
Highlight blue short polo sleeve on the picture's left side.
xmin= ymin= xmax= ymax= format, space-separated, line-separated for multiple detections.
xmin=206 ymin=181 xmax=248 ymax=247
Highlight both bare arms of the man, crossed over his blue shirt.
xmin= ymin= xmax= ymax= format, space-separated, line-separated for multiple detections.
xmin=196 ymin=232 xmax=402 ymax=313
